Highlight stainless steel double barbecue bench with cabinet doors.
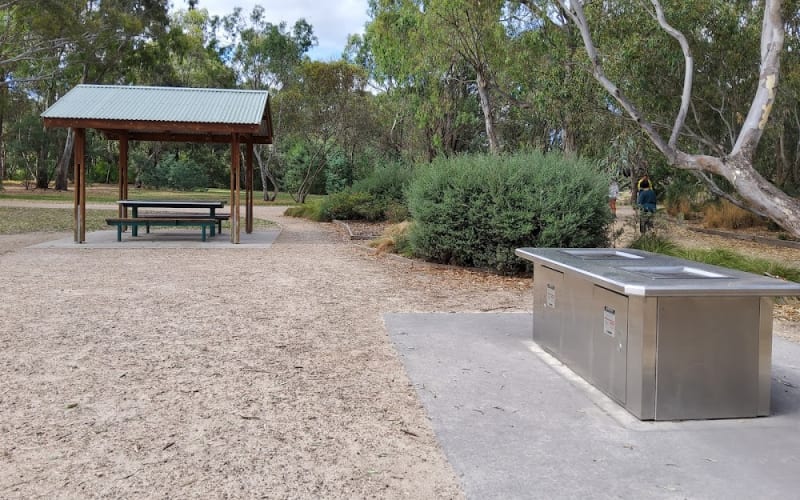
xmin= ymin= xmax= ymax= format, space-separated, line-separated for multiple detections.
xmin=516 ymin=248 xmax=800 ymax=420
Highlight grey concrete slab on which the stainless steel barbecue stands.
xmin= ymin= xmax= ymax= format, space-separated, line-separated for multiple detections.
xmin=384 ymin=313 xmax=800 ymax=500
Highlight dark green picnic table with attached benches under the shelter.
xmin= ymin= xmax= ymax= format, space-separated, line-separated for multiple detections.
xmin=106 ymin=200 xmax=230 ymax=241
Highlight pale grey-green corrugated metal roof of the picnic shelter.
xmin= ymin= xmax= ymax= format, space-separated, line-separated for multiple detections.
xmin=42 ymin=85 xmax=269 ymax=125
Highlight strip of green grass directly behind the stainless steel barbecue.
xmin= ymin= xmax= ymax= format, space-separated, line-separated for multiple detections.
xmin=630 ymin=233 xmax=800 ymax=283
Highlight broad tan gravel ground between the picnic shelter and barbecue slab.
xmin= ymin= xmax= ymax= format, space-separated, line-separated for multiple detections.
xmin=0 ymin=208 xmax=531 ymax=498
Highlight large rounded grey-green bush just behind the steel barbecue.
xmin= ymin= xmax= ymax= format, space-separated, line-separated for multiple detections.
xmin=407 ymin=153 xmax=611 ymax=272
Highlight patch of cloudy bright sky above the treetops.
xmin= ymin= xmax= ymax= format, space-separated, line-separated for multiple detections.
xmin=172 ymin=0 xmax=367 ymax=61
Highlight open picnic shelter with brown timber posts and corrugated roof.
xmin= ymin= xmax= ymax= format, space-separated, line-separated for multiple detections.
xmin=42 ymin=85 xmax=273 ymax=243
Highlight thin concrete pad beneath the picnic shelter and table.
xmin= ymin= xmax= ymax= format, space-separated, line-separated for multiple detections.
xmin=30 ymin=227 xmax=281 ymax=249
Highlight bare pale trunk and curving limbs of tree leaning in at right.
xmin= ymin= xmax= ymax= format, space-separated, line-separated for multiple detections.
xmin=558 ymin=0 xmax=800 ymax=237
